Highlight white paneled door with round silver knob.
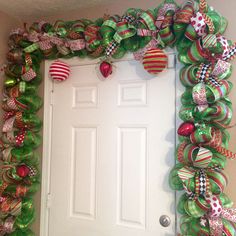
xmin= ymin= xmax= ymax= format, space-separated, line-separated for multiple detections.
xmin=45 ymin=55 xmax=176 ymax=236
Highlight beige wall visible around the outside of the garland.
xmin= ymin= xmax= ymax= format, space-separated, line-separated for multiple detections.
xmin=0 ymin=0 xmax=236 ymax=236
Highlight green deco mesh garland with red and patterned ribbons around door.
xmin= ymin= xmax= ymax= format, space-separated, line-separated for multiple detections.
xmin=0 ymin=0 xmax=236 ymax=236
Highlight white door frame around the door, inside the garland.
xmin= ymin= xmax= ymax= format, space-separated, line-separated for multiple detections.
xmin=40 ymin=52 xmax=179 ymax=236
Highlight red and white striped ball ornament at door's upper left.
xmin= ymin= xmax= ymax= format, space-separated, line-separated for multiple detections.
xmin=49 ymin=60 xmax=70 ymax=81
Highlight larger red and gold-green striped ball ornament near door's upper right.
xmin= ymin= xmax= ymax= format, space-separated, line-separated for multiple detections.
xmin=143 ymin=48 xmax=168 ymax=75
